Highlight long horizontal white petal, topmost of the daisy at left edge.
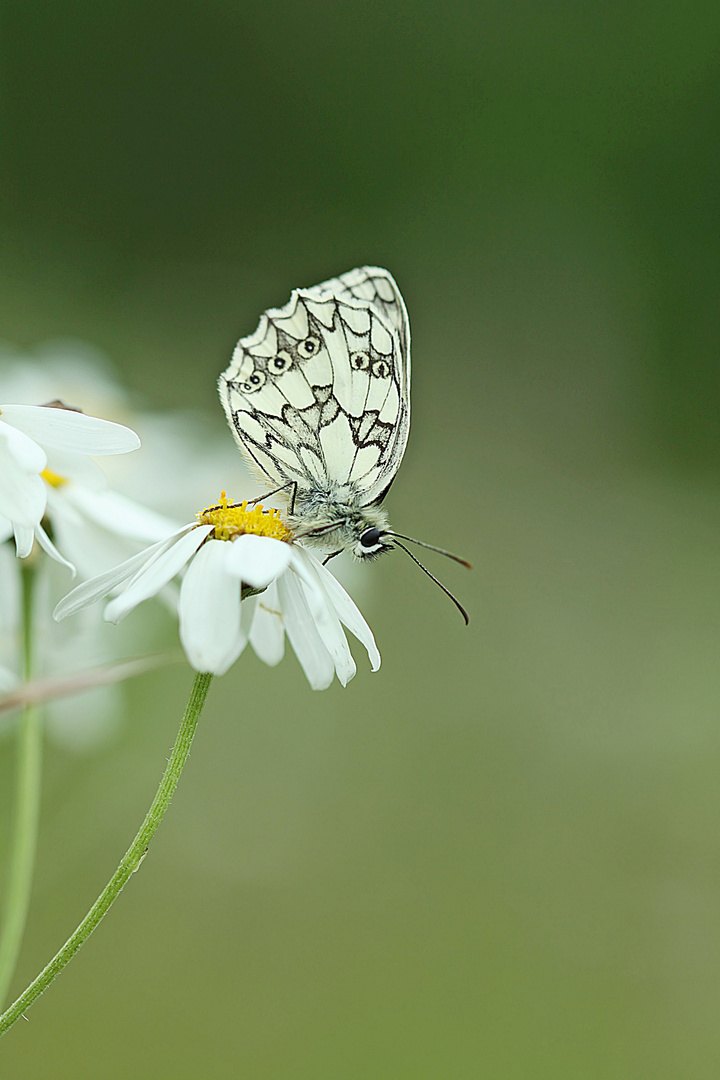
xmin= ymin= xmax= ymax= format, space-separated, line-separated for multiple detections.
xmin=0 ymin=405 xmax=140 ymax=455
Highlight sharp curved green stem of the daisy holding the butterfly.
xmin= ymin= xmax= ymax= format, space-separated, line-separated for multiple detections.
xmin=0 ymin=673 xmax=213 ymax=1036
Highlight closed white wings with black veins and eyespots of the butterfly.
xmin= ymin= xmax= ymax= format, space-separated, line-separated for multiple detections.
xmin=219 ymin=268 xmax=410 ymax=505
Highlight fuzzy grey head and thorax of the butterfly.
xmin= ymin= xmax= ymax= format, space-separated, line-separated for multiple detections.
xmin=288 ymin=484 xmax=391 ymax=558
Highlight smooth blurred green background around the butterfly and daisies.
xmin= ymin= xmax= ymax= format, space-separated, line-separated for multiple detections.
xmin=0 ymin=0 xmax=720 ymax=1080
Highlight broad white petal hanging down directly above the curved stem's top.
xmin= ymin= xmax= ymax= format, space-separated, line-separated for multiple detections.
xmin=179 ymin=540 xmax=247 ymax=675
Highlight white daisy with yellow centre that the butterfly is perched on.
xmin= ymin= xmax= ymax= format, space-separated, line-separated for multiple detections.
xmin=54 ymin=491 xmax=380 ymax=690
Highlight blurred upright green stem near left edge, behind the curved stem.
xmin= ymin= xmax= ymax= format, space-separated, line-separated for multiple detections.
xmin=0 ymin=559 xmax=42 ymax=1009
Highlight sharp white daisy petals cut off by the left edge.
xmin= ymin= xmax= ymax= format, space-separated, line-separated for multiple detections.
xmin=0 ymin=404 xmax=140 ymax=569
